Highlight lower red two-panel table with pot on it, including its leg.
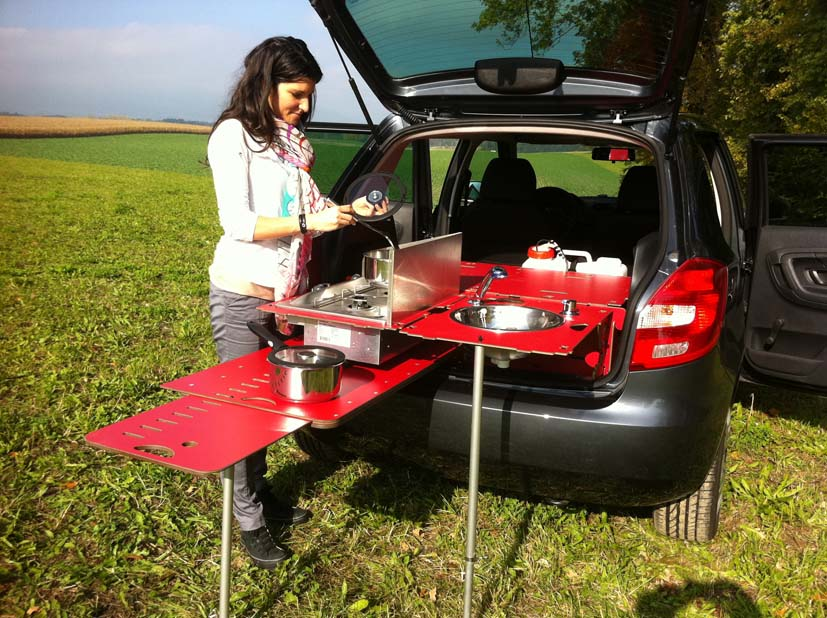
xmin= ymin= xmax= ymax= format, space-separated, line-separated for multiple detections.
xmin=86 ymin=341 xmax=457 ymax=618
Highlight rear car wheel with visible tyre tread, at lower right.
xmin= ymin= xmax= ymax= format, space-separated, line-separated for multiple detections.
xmin=653 ymin=422 xmax=729 ymax=542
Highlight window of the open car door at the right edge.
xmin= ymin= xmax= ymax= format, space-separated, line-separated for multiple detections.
xmin=766 ymin=144 xmax=827 ymax=227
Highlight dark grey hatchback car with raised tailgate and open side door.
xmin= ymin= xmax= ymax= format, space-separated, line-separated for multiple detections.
xmin=297 ymin=0 xmax=827 ymax=541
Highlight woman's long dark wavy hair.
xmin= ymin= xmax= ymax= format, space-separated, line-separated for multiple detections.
xmin=212 ymin=36 xmax=322 ymax=150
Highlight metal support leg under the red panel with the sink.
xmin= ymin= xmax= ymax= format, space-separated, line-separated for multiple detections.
xmin=462 ymin=345 xmax=485 ymax=618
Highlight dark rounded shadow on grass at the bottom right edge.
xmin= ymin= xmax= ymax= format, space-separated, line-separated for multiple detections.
xmin=635 ymin=579 xmax=764 ymax=618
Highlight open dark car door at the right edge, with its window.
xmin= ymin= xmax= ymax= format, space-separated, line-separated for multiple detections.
xmin=744 ymin=135 xmax=827 ymax=391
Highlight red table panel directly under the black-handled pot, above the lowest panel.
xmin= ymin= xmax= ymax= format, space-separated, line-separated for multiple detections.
xmin=163 ymin=341 xmax=457 ymax=428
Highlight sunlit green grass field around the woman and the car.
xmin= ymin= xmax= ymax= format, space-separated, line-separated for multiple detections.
xmin=0 ymin=131 xmax=827 ymax=618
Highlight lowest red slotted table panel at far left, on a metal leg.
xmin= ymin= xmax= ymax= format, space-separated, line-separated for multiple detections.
xmin=86 ymin=396 xmax=308 ymax=474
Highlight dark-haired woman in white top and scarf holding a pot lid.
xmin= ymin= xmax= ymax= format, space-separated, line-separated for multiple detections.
xmin=207 ymin=37 xmax=361 ymax=568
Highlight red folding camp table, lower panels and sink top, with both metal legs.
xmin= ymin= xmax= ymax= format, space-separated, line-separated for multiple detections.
xmin=86 ymin=262 xmax=629 ymax=618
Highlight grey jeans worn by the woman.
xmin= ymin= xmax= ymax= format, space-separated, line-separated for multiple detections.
xmin=210 ymin=284 xmax=275 ymax=530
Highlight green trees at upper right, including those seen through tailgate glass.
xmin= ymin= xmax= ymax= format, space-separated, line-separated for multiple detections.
xmin=474 ymin=0 xmax=827 ymax=174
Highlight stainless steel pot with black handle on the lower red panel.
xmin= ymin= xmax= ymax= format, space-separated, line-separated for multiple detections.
xmin=247 ymin=322 xmax=345 ymax=403
